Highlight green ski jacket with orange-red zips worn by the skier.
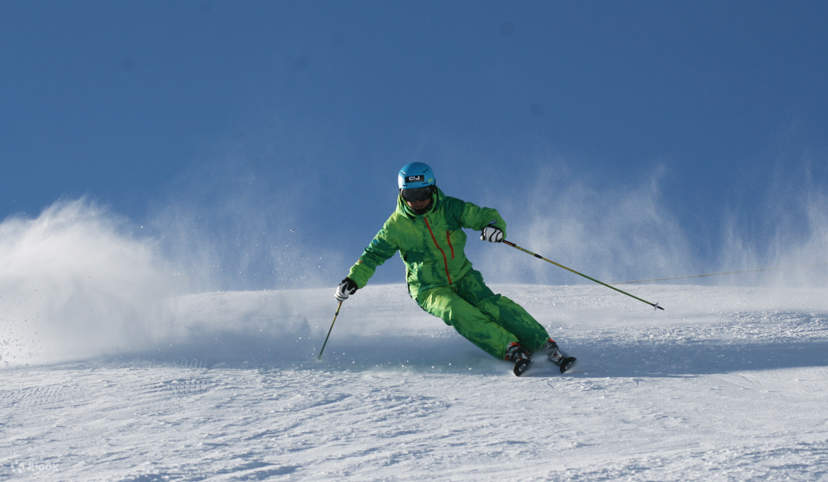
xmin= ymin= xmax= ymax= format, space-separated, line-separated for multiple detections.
xmin=348 ymin=189 xmax=506 ymax=299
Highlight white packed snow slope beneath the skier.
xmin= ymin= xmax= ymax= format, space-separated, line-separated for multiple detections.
xmin=0 ymin=285 xmax=828 ymax=480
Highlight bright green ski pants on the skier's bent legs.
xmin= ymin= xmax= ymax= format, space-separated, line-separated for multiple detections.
xmin=416 ymin=270 xmax=549 ymax=359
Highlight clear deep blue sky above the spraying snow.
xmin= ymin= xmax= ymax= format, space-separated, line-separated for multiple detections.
xmin=0 ymin=0 xmax=828 ymax=287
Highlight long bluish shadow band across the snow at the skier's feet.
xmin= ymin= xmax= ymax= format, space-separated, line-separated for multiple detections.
xmin=85 ymin=334 xmax=828 ymax=377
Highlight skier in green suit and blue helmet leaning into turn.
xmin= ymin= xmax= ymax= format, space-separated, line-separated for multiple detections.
xmin=336 ymin=162 xmax=575 ymax=376
